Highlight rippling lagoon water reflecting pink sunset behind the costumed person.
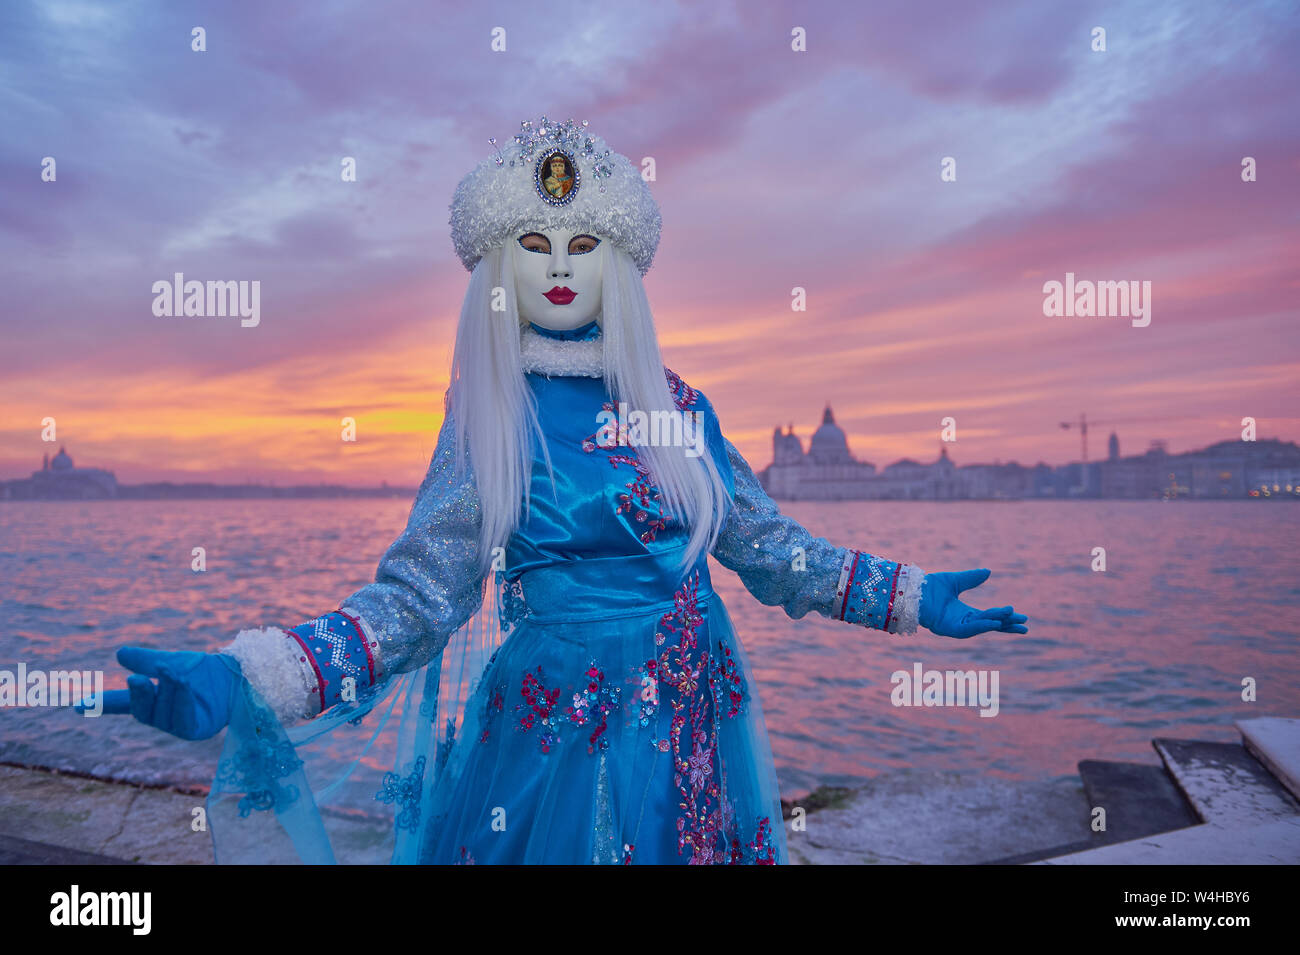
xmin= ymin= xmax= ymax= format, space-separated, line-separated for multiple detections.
xmin=0 ymin=499 xmax=1300 ymax=795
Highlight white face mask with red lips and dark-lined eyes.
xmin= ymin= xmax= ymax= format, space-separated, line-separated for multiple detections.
xmin=508 ymin=230 xmax=605 ymax=331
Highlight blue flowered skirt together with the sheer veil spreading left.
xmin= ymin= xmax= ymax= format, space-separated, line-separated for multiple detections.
xmin=209 ymin=564 xmax=785 ymax=864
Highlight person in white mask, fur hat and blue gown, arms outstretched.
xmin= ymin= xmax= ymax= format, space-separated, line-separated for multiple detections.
xmin=86 ymin=118 xmax=1027 ymax=864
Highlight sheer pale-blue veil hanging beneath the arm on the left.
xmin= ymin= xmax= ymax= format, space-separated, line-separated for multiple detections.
xmin=207 ymin=579 xmax=502 ymax=864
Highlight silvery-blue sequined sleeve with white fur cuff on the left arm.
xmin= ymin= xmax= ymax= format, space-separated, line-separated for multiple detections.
xmin=224 ymin=414 xmax=484 ymax=722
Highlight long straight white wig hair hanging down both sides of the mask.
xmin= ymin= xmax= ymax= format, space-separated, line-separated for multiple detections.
xmin=449 ymin=243 xmax=728 ymax=570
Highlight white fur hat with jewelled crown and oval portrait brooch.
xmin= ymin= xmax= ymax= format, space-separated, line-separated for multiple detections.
xmin=451 ymin=116 xmax=660 ymax=275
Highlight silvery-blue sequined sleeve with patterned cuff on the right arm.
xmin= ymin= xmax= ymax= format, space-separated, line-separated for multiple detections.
xmin=712 ymin=439 xmax=926 ymax=633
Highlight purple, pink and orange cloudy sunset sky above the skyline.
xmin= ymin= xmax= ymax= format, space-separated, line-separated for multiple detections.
xmin=0 ymin=0 xmax=1300 ymax=486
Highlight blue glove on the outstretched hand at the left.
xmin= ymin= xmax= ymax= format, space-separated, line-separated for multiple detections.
xmin=75 ymin=647 xmax=243 ymax=739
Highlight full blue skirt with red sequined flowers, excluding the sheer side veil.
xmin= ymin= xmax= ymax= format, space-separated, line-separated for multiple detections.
xmin=419 ymin=579 xmax=781 ymax=863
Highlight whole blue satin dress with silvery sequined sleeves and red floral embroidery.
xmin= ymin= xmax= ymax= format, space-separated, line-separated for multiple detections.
xmin=209 ymin=324 xmax=919 ymax=864
